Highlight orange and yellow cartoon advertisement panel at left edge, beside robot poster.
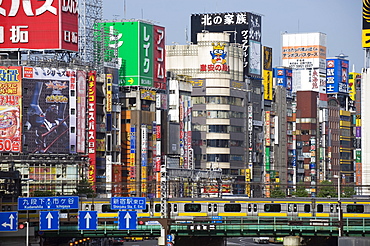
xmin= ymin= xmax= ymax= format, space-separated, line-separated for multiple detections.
xmin=0 ymin=67 xmax=22 ymax=153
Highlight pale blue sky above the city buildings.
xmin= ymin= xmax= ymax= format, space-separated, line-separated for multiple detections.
xmin=103 ymin=0 xmax=365 ymax=72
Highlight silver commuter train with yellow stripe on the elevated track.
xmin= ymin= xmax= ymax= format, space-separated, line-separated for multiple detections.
xmin=0 ymin=197 xmax=370 ymax=220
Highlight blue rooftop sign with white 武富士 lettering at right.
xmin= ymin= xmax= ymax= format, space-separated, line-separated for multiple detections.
xmin=326 ymin=59 xmax=349 ymax=94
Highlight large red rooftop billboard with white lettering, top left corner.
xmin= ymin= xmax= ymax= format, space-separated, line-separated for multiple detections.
xmin=0 ymin=0 xmax=78 ymax=51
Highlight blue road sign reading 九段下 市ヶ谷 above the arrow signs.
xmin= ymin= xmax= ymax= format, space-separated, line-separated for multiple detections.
xmin=18 ymin=196 xmax=78 ymax=210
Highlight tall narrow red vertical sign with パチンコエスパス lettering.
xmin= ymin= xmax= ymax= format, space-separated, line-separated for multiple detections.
xmin=87 ymin=71 xmax=96 ymax=190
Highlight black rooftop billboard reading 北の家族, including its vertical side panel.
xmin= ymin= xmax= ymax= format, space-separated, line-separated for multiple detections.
xmin=191 ymin=12 xmax=262 ymax=78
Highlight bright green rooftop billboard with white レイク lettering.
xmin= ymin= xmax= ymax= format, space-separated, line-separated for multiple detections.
xmin=103 ymin=21 xmax=154 ymax=87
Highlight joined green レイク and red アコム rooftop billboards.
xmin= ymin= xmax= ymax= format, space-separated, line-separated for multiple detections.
xmin=98 ymin=21 xmax=165 ymax=89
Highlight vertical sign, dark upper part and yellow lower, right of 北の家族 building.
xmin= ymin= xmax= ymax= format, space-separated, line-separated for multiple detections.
xmin=263 ymin=46 xmax=272 ymax=100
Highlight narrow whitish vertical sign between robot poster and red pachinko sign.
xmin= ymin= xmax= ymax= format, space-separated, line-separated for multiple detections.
xmin=76 ymin=70 xmax=86 ymax=153
